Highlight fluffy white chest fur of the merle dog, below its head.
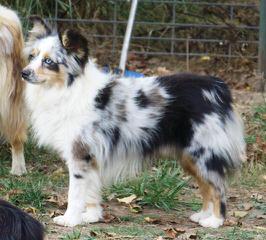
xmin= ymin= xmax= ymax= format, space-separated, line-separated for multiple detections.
xmin=26 ymin=84 xmax=93 ymax=158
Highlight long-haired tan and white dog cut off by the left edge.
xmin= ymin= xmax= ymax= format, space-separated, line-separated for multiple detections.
xmin=0 ymin=5 xmax=27 ymax=175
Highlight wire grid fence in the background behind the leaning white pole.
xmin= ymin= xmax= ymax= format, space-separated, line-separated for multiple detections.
xmin=45 ymin=0 xmax=259 ymax=61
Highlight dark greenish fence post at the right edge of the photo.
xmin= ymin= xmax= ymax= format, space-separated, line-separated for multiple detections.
xmin=259 ymin=0 xmax=266 ymax=91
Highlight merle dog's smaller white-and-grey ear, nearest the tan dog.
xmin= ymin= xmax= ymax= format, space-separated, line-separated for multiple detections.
xmin=29 ymin=15 xmax=52 ymax=41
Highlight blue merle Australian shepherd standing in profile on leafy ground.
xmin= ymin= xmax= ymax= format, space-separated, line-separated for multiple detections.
xmin=22 ymin=17 xmax=245 ymax=228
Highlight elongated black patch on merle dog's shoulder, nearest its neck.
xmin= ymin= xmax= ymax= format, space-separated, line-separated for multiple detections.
xmin=95 ymin=82 xmax=116 ymax=110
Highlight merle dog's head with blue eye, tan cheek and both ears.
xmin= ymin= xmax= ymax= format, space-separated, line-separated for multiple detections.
xmin=22 ymin=16 xmax=89 ymax=87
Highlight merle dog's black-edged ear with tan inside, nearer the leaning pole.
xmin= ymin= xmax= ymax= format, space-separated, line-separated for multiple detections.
xmin=59 ymin=29 xmax=89 ymax=67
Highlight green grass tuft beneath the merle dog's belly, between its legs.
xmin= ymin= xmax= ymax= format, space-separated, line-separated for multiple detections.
xmin=106 ymin=161 xmax=187 ymax=210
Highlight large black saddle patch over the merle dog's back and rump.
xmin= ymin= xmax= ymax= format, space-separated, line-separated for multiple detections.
xmin=137 ymin=74 xmax=232 ymax=156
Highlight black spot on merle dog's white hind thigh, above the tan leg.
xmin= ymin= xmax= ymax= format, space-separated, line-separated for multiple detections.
xmin=206 ymin=154 xmax=228 ymax=177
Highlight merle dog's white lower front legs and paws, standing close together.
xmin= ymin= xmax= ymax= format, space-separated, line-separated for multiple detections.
xmin=54 ymin=160 xmax=102 ymax=227
